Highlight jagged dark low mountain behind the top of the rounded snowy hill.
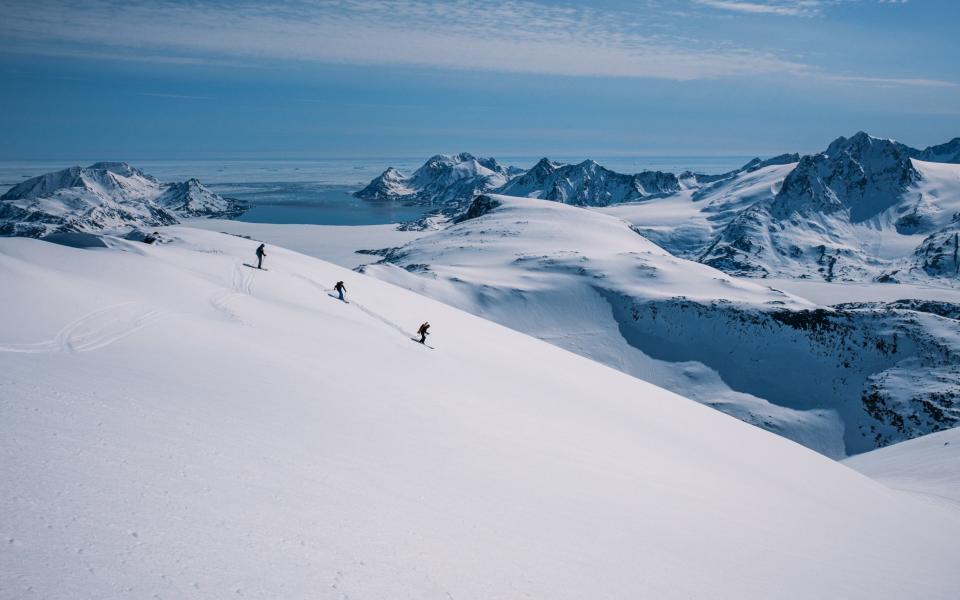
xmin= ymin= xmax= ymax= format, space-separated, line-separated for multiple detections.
xmin=497 ymin=158 xmax=680 ymax=206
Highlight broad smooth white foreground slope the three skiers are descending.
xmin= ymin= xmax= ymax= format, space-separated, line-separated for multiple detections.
xmin=0 ymin=228 xmax=960 ymax=600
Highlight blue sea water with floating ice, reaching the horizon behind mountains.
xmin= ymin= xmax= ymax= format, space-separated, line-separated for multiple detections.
xmin=0 ymin=156 xmax=752 ymax=225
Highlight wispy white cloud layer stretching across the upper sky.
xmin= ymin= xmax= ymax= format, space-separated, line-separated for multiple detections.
xmin=0 ymin=0 xmax=949 ymax=86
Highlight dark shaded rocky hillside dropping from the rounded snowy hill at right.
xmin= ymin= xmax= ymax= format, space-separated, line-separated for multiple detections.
xmin=614 ymin=298 xmax=960 ymax=454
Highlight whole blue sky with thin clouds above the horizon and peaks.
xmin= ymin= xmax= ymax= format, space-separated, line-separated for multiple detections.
xmin=0 ymin=0 xmax=960 ymax=160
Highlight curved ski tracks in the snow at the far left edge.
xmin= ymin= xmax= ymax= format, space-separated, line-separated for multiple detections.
xmin=0 ymin=302 xmax=165 ymax=354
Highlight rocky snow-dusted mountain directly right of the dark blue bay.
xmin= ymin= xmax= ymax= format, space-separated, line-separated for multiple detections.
xmin=354 ymin=152 xmax=516 ymax=206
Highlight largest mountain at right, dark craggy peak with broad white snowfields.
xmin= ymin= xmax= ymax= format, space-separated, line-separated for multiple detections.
xmin=600 ymin=133 xmax=960 ymax=285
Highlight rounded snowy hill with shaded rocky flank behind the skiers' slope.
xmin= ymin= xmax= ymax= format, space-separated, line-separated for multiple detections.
xmin=363 ymin=196 xmax=960 ymax=457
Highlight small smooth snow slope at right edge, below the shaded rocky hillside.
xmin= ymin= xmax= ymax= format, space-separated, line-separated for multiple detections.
xmin=844 ymin=428 xmax=960 ymax=516
